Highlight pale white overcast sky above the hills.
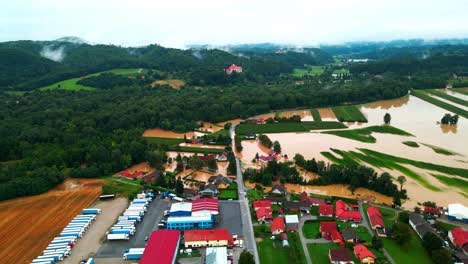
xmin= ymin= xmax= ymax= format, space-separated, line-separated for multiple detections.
xmin=0 ymin=0 xmax=468 ymax=48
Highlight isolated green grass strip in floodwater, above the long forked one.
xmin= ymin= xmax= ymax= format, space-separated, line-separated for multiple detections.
xmin=322 ymin=126 xmax=413 ymax=143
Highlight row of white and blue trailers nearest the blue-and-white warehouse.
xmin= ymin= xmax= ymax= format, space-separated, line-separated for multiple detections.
xmin=107 ymin=197 xmax=152 ymax=240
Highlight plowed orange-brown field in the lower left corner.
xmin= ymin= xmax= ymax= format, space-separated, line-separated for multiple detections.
xmin=0 ymin=179 xmax=104 ymax=264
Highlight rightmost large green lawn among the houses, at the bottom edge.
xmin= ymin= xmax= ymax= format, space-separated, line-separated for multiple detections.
xmin=383 ymin=234 xmax=432 ymax=264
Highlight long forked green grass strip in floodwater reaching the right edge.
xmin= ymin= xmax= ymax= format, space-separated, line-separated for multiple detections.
xmin=322 ymin=149 xmax=468 ymax=191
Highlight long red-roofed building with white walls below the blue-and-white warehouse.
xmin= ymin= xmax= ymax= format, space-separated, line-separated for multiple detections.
xmin=184 ymin=229 xmax=233 ymax=248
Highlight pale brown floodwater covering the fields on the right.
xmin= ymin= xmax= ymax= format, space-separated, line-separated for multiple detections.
xmin=242 ymin=96 xmax=468 ymax=208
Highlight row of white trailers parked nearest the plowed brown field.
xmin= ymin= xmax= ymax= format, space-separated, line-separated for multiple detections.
xmin=31 ymin=208 xmax=101 ymax=264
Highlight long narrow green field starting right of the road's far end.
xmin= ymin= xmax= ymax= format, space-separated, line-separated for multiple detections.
xmin=236 ymin=121 xmax=346 ymax=135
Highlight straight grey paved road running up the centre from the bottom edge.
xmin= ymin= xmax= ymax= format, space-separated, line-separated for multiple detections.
xmin=230 ymin=125 xmax=260 ymax=264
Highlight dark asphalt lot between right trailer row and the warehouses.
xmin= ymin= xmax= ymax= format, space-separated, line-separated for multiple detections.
xmin=96 ymin=197 xmax=171 ymax=258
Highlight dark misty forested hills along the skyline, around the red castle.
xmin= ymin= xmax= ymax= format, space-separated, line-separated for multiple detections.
xmin=0 ymin=39 xmax=331 ymax=90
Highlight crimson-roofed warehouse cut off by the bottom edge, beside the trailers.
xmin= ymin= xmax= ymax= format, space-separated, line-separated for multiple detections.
xmin=139 ymin=230 xmax=180 ymax=264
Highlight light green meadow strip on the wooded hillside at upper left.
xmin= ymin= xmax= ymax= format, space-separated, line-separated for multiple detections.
xmin=39 ymin=69 xmax=147 ymax=91
